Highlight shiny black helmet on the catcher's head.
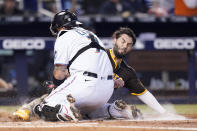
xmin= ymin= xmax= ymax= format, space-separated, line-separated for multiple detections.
xmin=50 ymin=10 xmax=82 ymax=35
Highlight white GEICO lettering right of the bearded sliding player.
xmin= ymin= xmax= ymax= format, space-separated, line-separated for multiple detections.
xmin=154 ymin=39 xmax=195 ymax=50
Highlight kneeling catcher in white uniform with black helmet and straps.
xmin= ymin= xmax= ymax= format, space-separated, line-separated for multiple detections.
xmin=14 ymin=10 xmax=141 ymax=121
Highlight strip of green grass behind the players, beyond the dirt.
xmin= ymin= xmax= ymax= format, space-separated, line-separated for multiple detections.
xmin=0 ymin=104 xmax=197 ymax=114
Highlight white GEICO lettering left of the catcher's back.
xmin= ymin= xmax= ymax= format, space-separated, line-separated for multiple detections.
xmin=2 ymin=39 xmax=45 ymax=50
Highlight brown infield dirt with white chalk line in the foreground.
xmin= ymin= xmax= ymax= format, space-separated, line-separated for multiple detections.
xmin=0 ymin=112 xmax=197 ymax=131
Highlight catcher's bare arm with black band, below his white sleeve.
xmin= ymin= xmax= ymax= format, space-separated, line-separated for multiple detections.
xmin=53 ymin=64 xmax=69 ymax=86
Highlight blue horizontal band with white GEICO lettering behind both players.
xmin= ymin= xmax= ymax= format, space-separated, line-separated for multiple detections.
xmin=0 ymin=37 xmax=197 ymax=50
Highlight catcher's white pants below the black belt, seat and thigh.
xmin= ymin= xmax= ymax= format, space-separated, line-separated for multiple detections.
xmin=45 ymin=73 xmax=114 ymax=114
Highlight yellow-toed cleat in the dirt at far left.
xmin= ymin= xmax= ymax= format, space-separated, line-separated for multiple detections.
xmin=13 ymin=109 xmax=30 ymax=121
